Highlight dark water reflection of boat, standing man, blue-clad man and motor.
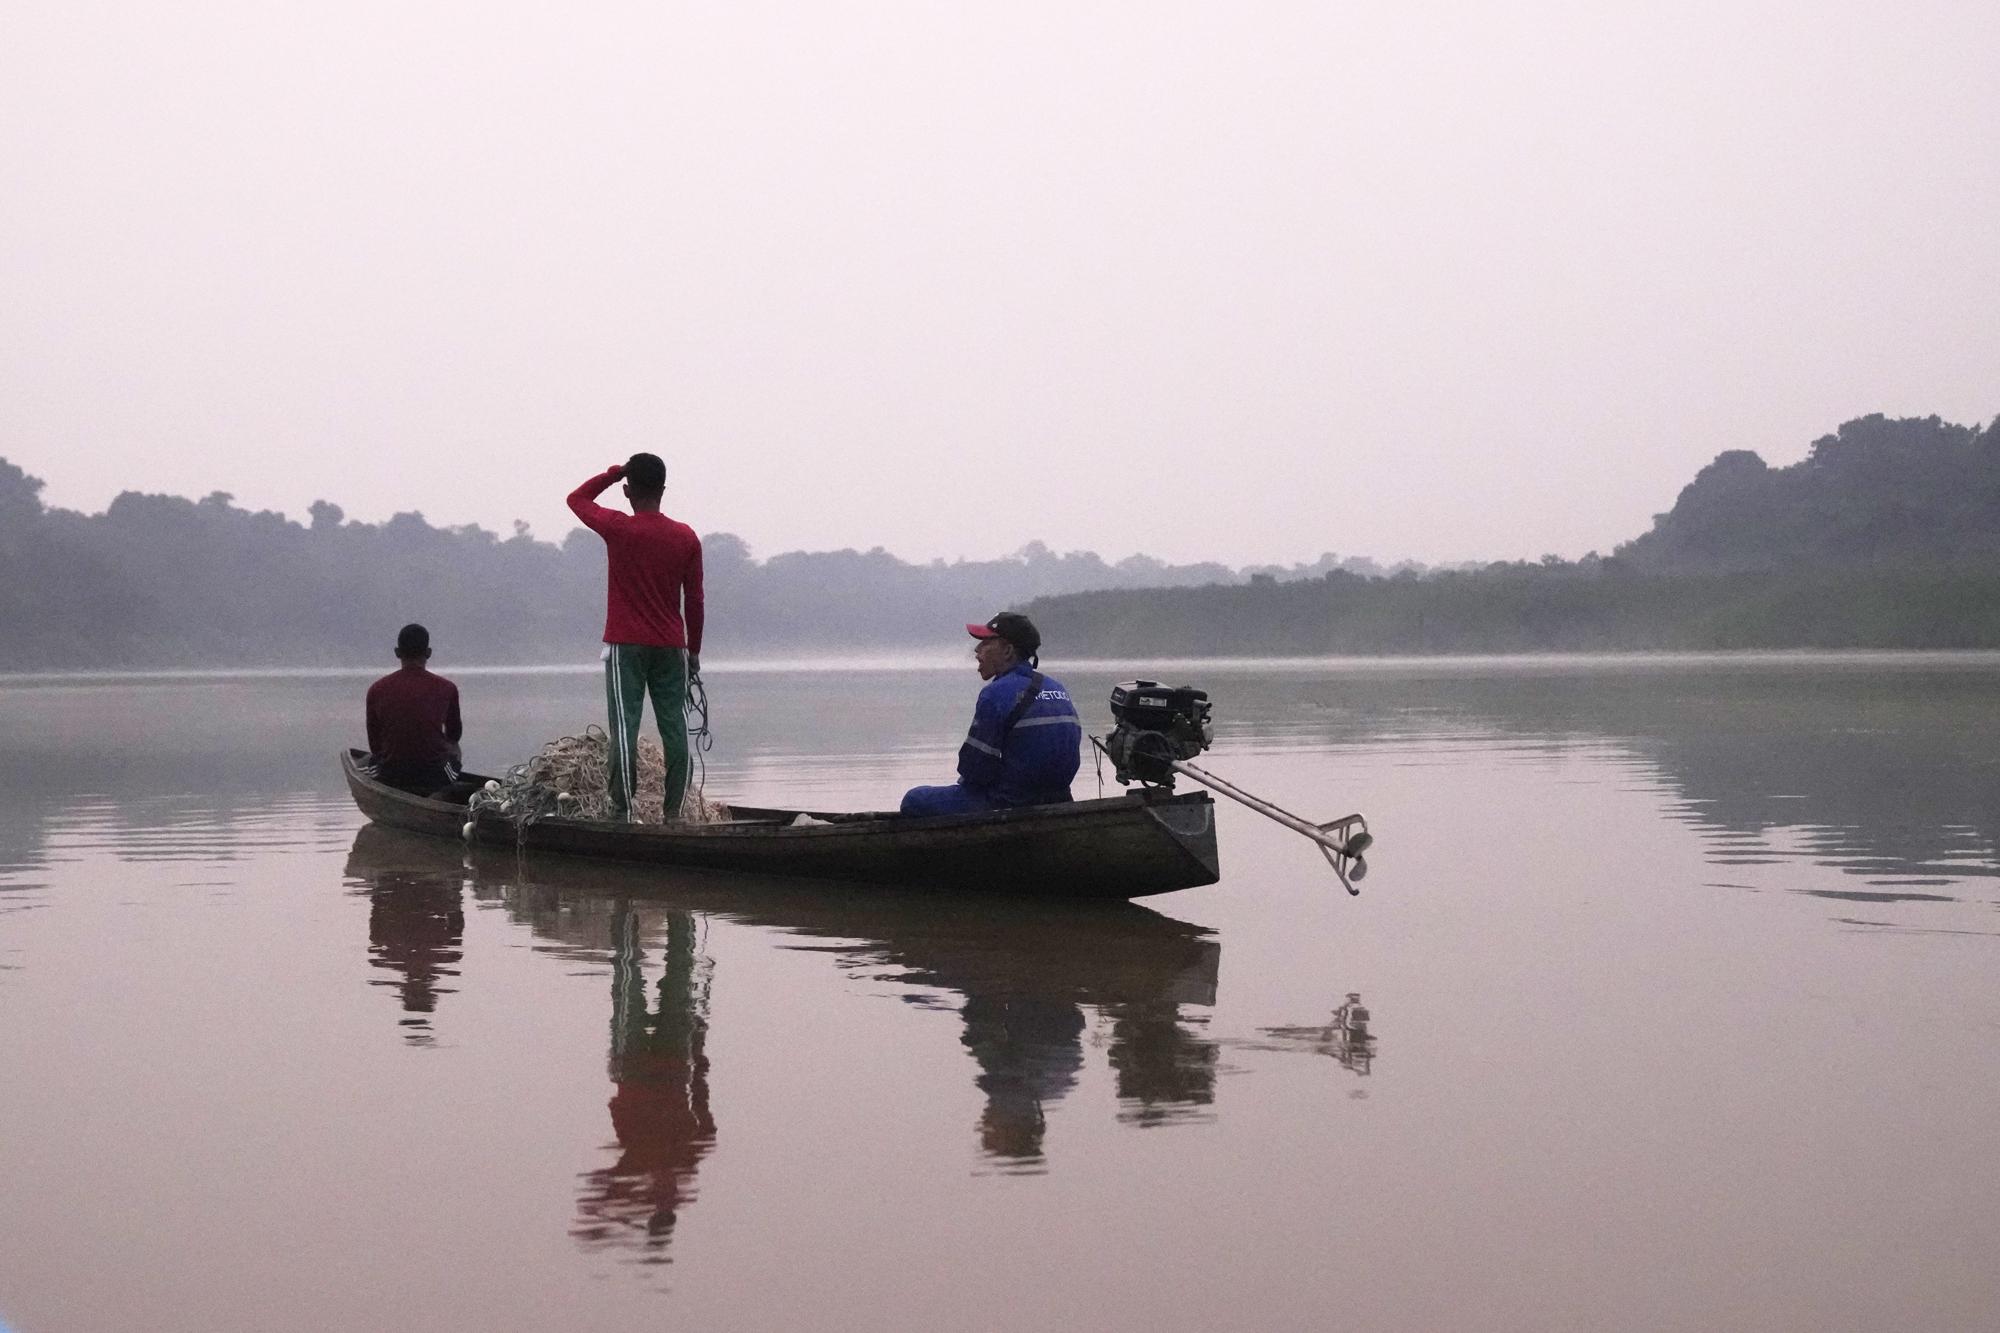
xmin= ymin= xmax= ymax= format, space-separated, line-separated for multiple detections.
xmin=348 ymin=825 xmax=1222 ymax=1184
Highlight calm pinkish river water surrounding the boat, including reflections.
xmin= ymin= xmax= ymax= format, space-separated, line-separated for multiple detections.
xmin=0 ymin=656 xmax=2000 ymax=1333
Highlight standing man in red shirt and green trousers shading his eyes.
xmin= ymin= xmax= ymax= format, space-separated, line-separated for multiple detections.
xmin=570 ymin=454 xmax=702 ymax=821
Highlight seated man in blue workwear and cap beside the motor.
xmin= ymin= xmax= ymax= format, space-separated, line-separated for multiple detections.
xmin=902 ymin=610 xmax=1084 ymax=815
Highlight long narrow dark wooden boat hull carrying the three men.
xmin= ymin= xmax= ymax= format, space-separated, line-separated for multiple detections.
xmin=340 ymin=751 xmax=1222 ymax=899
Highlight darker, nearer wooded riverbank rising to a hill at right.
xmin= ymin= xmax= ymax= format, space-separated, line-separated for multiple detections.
xmin=1030 ymin=416 xmax=2000 ymax=656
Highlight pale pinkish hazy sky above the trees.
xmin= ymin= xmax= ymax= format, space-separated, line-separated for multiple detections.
xmin=0 ymin=0 xmax=2000 ymax=562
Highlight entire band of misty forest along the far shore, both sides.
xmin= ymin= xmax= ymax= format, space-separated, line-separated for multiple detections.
xmin=0 ymin=416 xmax=2000 ymax=671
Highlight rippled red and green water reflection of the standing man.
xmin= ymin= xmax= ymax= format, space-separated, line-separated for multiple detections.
xmin=574 ymin=907 xmax=716 ymax=1263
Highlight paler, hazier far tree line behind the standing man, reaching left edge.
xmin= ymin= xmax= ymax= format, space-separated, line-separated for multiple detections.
xmin=0 ymin=458 xmax=1380 ymax=671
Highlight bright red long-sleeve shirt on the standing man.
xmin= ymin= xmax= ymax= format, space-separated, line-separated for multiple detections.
xmin=570 ymin=468 xmax=702 ymax=652
